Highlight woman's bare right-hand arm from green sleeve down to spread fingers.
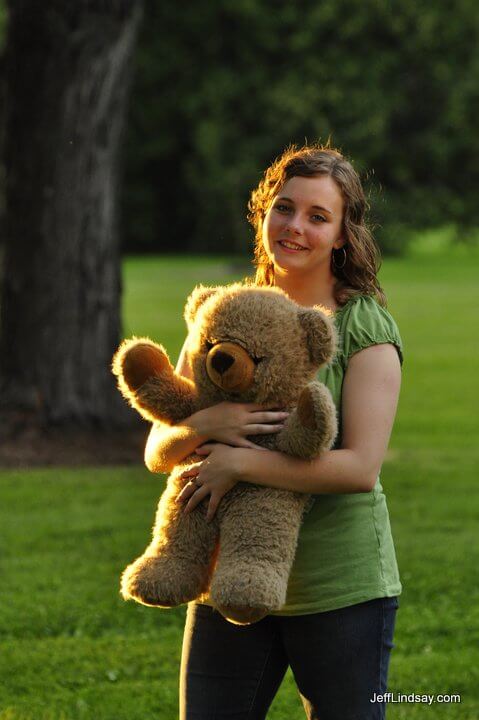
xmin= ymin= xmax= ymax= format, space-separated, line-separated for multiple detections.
xmin=180 ymin=344 xmax=401 ymax=516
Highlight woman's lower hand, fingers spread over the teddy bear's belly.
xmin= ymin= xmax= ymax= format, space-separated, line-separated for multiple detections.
xmin=176 ymin=444 xmax=251 ymax=522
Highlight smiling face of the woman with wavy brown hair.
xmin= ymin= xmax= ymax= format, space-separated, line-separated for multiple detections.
xmin=263 ymin=175 xmax=344 ymax=272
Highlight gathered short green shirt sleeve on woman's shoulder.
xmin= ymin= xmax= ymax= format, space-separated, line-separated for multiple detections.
xmin=340 ymin=296 xmax=403 ymax=365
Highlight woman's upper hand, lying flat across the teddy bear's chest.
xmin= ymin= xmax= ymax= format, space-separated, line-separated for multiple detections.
xmin=192 ymin=401 xmax=289 ymax=450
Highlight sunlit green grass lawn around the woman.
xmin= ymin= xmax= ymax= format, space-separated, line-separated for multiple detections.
xmin=0 ymin=248 xmax=479 ymax=720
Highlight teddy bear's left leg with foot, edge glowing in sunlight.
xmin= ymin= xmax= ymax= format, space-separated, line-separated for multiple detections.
xmin=121 ymin=476 xmax=218 ymax=607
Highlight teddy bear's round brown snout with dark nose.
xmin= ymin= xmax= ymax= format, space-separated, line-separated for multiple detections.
xmin=206 ymin=342 xmax=255 ymax=392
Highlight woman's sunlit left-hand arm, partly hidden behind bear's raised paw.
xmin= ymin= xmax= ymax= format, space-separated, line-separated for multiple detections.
xmin=145 ymin=342 xmax=288 ymax=472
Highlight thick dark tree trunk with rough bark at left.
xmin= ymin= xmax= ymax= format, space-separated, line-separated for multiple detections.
xmin=0 ymin=0 xmax=141 ymax=426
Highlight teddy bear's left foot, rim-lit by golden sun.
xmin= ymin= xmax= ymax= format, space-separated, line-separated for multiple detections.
xmin=121 ymin=557 xmax=208 ymax=608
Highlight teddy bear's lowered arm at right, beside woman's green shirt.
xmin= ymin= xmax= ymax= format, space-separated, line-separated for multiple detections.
xmin=277 ymin=381 xmax=337 ymax=460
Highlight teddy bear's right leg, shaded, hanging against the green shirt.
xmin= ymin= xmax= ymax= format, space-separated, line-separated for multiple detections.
xmin=210 ymin=486 xmax=307 ymax=625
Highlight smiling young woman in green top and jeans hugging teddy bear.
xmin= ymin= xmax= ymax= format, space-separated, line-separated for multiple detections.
xmin=145 ymin=146 xmax=402 ymax=720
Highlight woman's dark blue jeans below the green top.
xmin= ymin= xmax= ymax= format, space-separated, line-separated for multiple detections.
xmin=180 ymin=597 xmax=398 ymax=720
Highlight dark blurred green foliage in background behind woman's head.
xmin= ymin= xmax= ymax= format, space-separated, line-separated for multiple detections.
xmin=123 ymin=0 xmax=479 ymax=252
